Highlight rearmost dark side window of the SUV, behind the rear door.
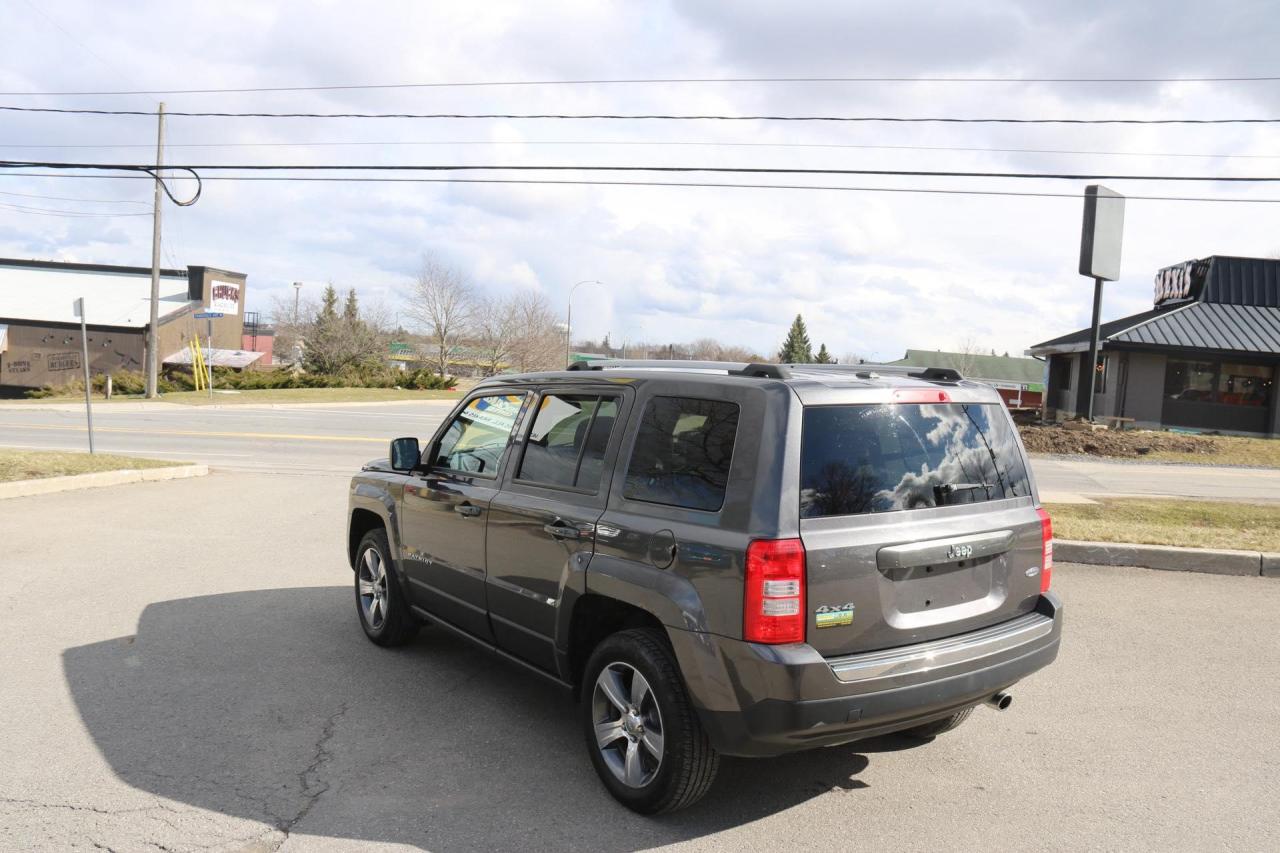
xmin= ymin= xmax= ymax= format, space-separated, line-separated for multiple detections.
xmin=622 ymin=397 xmax=739 ymax=512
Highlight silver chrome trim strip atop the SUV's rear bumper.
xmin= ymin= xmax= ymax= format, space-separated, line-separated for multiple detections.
xmin=827 ymin=613 xmax=1053 ymax=683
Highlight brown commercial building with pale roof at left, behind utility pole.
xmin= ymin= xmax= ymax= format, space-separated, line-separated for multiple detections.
xmin=0 ymin=259 xmax=252 ymax=389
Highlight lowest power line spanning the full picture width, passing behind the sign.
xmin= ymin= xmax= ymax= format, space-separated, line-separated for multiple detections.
xmin=0 ymin=172 xmax=1280 ymax=202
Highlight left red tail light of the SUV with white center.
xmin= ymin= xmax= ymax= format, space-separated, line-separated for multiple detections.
xmin=742 ymin=539 xmax=805 ymax=643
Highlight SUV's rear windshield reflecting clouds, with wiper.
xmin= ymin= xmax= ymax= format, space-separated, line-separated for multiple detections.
xmin=800 ymin=403 xmax=1030 ymax=519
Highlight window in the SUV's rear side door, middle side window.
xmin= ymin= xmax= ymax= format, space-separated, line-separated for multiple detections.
xmin=517 ymin=394 xmax=618 ymax=492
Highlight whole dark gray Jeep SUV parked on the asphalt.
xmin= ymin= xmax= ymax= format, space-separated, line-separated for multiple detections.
xmin=348 ymin=361 xmax=1062 ymax=813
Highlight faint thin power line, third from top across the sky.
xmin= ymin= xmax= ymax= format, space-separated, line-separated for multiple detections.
xmin=0 ymin=138 xmax=1280 ymax=160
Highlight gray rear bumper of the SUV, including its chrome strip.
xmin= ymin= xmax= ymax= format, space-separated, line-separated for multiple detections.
xmin=671 ymin=593 xmax=1062 ymax=756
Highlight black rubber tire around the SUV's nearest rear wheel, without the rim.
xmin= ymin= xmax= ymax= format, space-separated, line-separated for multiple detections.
xmin=581 ymin=633 xmax=687 ymax=813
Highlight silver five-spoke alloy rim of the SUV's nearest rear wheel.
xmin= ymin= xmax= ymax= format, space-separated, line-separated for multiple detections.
xmin=591 ymin=661 xmax=664 ymax=788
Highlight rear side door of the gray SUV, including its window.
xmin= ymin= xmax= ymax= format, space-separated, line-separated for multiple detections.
xmin=485 ymin=388 xmax=626 ymax=670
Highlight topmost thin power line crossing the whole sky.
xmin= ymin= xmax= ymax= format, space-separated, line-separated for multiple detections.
xmin=0 ymin=76 xmax=1280 ymax=97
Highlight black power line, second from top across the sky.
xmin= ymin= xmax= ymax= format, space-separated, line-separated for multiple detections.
xmin=0 ymin=105 xmax=1280 ymax=124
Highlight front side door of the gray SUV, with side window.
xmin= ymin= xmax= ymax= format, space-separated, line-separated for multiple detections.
xmin=401 ymin=391 xmax=526 ymax=640
